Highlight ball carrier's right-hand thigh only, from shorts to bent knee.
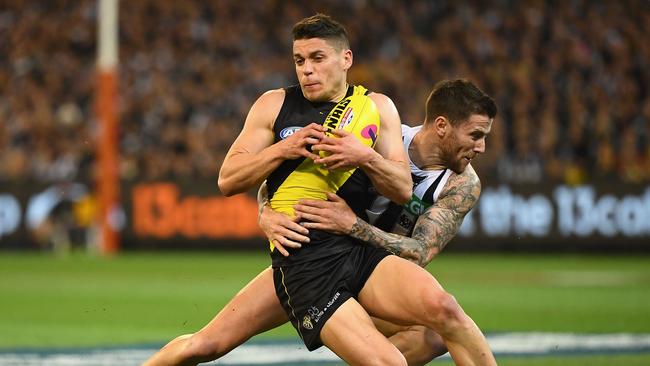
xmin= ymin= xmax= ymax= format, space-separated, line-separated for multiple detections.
xmin=359 ymin=255 xmax=446 ymax=325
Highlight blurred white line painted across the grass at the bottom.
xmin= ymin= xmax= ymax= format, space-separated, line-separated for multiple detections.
xmin=0 ymin=332 xmax=650 ymax=366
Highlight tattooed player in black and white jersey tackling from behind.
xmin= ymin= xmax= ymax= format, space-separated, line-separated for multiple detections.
xmin=260 ymin=79 xmax=496 ymax=365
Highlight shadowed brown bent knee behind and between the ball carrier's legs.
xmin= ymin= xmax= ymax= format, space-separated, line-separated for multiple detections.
xmin=372 ymin=318 xmax=447 ymax=366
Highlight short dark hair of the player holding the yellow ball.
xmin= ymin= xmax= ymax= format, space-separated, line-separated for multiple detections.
xmin=293 ymin=13 xmax=350 ymax=50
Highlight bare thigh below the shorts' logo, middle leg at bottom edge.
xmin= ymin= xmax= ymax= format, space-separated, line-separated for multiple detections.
xmin=320 ymin=298 xmax=406 ymax=365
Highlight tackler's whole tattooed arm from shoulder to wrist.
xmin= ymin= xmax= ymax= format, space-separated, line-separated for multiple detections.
xmin=350 ymin=167 xmax=481 ymax=267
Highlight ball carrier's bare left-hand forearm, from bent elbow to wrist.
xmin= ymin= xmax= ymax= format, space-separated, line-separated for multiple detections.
xmin=218 ymin=145 xmax=284 ymax=196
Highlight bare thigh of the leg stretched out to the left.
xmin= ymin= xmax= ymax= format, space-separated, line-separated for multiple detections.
xmin=197 ymin=268 xmax=289 ymax=348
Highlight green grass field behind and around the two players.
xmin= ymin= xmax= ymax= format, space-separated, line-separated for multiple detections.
xmin=0 ymin=252 xmax=650 ymax=365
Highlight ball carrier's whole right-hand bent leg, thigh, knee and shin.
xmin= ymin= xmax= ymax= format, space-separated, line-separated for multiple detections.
xmin=359 ymin=256 xmax=496 ymax=365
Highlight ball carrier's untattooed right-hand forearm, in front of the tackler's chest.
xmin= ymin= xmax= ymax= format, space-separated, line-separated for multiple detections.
xmin=361 ymin=152 xmax=413 ymax=204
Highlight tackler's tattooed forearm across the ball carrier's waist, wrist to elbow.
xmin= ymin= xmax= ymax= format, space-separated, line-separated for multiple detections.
xmin=350 ymin=217 xmax=437 ymax=267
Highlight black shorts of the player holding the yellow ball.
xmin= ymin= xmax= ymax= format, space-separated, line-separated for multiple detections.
xmin=273 ymin=244 xmax=391 ymax=351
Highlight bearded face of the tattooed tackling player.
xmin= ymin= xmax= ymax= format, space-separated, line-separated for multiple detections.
xmin=445 ymin=114 xmax=492 ymax=174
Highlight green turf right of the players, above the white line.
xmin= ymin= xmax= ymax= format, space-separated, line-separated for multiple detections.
xmin=429 ymin=255 xmax=650 ymax=332
